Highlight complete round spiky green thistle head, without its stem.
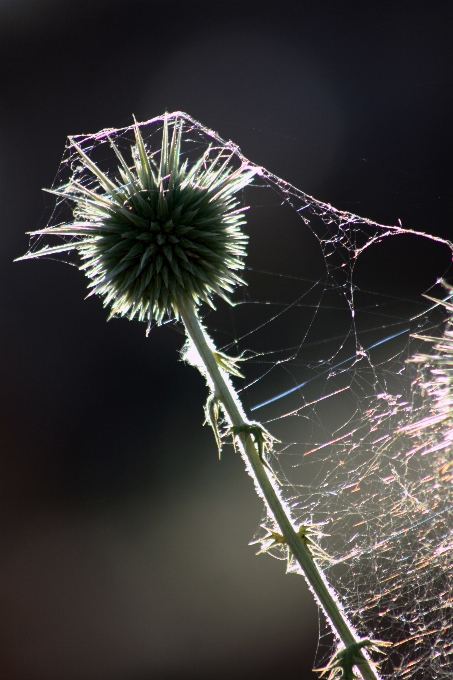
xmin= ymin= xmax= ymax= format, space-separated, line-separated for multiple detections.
xmin=25 ymin=117 xmax=258 ymax=323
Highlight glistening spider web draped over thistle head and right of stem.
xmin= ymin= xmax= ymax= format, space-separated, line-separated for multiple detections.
xmin=25 ymin=113 xmax=453 ymax=680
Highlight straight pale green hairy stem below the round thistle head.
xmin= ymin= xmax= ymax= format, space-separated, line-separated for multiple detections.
xmin=178 ymin=301 xmax=379 ymax=680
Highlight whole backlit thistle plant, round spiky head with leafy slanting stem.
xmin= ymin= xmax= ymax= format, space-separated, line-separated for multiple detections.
xmin=19 ymin=115 xmax=381 ymax=680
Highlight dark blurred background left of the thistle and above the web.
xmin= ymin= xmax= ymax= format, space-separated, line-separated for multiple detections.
xmin=0 ymin=0 xmax=453 ymax=680
